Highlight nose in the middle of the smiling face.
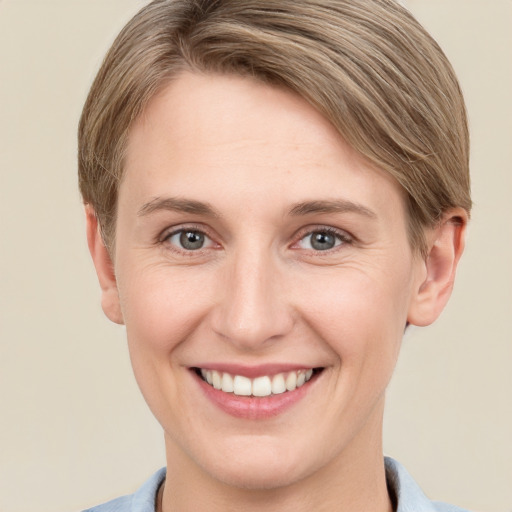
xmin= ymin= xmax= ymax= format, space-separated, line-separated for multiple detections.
xmin=213 ymin=248 xmax=293 ymax=351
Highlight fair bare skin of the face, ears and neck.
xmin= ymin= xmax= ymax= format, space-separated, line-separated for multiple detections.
xmin=86 ymin=72 xmax=467 ymax=511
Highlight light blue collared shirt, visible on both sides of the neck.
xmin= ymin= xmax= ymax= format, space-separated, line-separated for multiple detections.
xmin=83 ymin=457 xmax=468 ymax=512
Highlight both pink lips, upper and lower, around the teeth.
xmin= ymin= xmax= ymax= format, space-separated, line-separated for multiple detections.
xmin=190 ymin=364 xmax=320 ymax=420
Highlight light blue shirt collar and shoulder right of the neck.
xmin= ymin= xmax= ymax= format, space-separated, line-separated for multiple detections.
xmin=385 ymin=457 xmax=468 ymax=512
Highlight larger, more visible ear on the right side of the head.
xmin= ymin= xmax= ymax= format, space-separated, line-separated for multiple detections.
xmin=407 ymin=208 xmax=468 ymax=326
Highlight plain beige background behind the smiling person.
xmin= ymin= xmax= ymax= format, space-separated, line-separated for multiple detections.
xmin=0 ymin=0 xmax=512 ymax=512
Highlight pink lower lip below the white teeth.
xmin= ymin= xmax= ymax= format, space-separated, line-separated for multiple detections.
xmin=192 ymin=372 xmax=317 ymax=420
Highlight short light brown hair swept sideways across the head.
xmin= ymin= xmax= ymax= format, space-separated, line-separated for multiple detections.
xmin=78 ymin=0 xmax=471 ymax=251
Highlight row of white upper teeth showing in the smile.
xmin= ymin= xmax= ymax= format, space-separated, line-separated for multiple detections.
xmin=201 ymin=369 xmax=313 ymax=397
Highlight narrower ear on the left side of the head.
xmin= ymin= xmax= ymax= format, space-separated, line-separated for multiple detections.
xmin=85 ymin=205 xmax=124 ymax=324
